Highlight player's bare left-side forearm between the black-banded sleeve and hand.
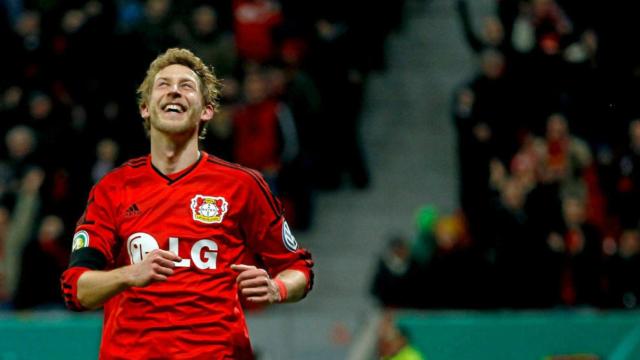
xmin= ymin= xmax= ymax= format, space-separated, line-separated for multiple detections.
xmin=77 ymin=267 xmax=131 ymax=310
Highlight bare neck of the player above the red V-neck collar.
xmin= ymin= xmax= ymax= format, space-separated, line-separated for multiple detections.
xmin=150 ymin=129 xmax=200 ymax=175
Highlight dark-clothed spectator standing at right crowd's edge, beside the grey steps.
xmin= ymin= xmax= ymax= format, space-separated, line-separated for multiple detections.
xmin=454 ymin=50 xmax=518 ymax=249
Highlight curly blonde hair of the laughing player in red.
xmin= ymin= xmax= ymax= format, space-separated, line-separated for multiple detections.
xmin=136 ymin=48 xmax=220 ymax=139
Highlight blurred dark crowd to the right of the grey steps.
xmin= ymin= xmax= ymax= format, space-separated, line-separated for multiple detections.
xmin=373 ymin=0 xmax=640 ymax=308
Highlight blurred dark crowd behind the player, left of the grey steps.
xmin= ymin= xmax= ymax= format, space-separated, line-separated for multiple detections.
xmin=0 ymin=0 xmax=403 ymax=309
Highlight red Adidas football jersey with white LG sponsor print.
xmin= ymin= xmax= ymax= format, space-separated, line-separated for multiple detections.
xmin=62 ymin=152 xmax=313 ymax=360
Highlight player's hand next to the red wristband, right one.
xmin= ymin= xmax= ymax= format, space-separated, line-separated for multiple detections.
xmin=231 ymin=264 xmax=281 ymax=304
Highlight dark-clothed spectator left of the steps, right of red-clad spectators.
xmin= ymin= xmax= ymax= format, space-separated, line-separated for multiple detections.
xmin=308 ymin=12 xmax=369 ymax=189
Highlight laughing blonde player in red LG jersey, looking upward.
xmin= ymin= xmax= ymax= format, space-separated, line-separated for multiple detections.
xmin=62 ymin=49 xmax=313 ymax=360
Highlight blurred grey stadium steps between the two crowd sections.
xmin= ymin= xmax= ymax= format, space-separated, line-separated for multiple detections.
xmin=249 ymin=0 xmax=478 ymax=360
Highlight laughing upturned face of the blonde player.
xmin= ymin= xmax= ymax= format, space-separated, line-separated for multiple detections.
xmin=140 ymin=64 xmax=213 ymax=134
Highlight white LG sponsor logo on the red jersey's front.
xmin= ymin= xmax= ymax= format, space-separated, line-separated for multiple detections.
xmin=127 ymin=232 xmax=218 ymax=270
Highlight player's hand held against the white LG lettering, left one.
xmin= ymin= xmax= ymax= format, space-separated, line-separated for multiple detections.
xmin=128 ymin=249 xmax=182 ymax=286
